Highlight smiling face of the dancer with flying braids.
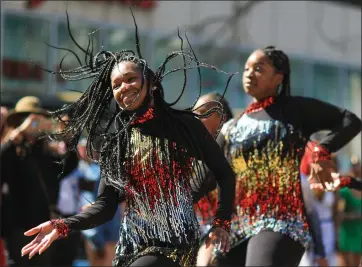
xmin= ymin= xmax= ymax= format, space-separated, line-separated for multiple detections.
xmin=111 ymin=61 xmax=147 ymax=110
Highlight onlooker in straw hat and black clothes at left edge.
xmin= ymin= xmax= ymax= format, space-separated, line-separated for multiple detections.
xmin=0 ymin=96 xmax=77 ymax=266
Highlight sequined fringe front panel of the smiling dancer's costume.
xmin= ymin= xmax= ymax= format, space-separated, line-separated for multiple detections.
xmin=117 ymin=128 xmax=199 ymax=262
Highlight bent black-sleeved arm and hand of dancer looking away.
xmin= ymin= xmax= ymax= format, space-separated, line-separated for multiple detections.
xmin=292 ymin=97 xmax=362 ymax=190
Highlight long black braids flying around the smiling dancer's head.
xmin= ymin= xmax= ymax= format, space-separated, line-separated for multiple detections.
xmin=36 ymin=10 xmax=236 ymax=193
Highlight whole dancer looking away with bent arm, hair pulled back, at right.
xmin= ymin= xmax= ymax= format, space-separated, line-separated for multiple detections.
xmin=217 ymin=46 xmax=362 ymax=266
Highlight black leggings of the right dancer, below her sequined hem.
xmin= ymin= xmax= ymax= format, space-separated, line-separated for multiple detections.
xmin=216 ymin=231 xmax=305 ymax=267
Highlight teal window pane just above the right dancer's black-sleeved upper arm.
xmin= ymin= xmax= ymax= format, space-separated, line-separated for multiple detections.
xmin=313 ymin=63 xmax=339 ymax=106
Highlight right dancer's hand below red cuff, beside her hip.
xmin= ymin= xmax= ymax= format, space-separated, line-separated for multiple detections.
xmin=308 ymin=160 xmax=339 ymax=191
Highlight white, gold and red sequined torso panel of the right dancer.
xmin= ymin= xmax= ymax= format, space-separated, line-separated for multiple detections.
xmin=223 ymin=111 xmax=311 ymax=249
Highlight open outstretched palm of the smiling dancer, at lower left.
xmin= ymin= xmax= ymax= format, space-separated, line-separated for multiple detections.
xmin=21 ymin=221 xmax=59 ymax=259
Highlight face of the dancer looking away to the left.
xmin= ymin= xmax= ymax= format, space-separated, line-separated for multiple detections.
xmin=243 ymin=50 xmax=283 ymax=100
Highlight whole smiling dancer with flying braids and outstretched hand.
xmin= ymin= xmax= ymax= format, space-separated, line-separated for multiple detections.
xmin=22 ymin=10 xmax=235 ymax=266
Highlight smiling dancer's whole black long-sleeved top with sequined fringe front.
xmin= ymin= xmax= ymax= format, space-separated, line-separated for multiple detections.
xmin=62 ymin=110 xmax=235 ymax=267
